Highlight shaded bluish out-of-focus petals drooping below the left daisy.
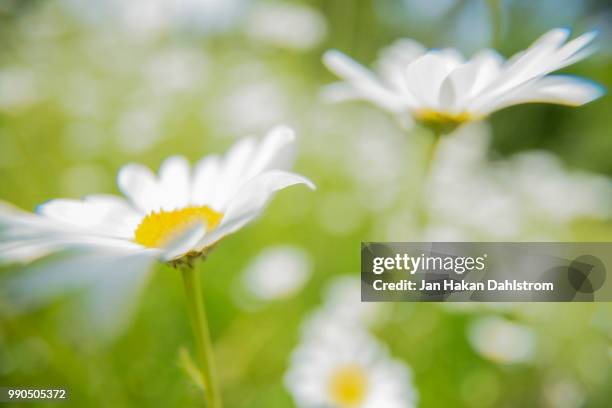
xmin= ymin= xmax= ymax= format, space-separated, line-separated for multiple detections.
xmin=4 ymin=250 xmax=155 ymax=340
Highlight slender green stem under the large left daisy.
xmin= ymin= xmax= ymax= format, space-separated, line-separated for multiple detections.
xmin=180 ymin=265 xmax=223 ymax=408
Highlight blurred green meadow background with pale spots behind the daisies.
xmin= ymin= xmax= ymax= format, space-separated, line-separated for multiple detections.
xmin=0 ymin=0 xmax=612 ymax=408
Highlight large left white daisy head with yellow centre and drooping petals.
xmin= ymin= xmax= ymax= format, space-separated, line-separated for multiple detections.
xmin=0 ymin=127 xmax=314 ymax=340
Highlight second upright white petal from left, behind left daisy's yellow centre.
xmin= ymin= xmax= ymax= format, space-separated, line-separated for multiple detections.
xmin=159 ymin=156 xmax=191 ymax=211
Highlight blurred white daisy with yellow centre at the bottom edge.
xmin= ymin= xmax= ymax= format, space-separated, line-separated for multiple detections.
xmin=285 ymin=325 xmax=417 ymax=408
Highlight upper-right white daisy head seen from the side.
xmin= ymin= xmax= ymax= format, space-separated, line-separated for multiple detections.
xmin=323 ymin=28 xmax=604 ymax=133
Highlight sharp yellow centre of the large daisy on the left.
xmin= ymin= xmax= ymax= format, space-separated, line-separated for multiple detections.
xmin=134 ymin=205 xmax=223 ymax=248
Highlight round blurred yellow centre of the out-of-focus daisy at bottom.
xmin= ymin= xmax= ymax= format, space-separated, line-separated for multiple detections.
xmin=329 ymin=365 xmax=368 ymax=408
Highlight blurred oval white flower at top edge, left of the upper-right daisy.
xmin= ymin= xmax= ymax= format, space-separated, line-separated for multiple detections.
xmin=247 ymin=3 xmax=327 ymax=50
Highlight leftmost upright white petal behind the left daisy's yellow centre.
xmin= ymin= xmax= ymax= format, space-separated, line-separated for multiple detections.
xmin=117 ymin=164 xmax=163 ymax=214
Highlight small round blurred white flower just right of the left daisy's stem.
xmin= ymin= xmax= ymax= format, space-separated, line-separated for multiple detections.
xmin=242 ymin=245 xmax=312 ymax=300
